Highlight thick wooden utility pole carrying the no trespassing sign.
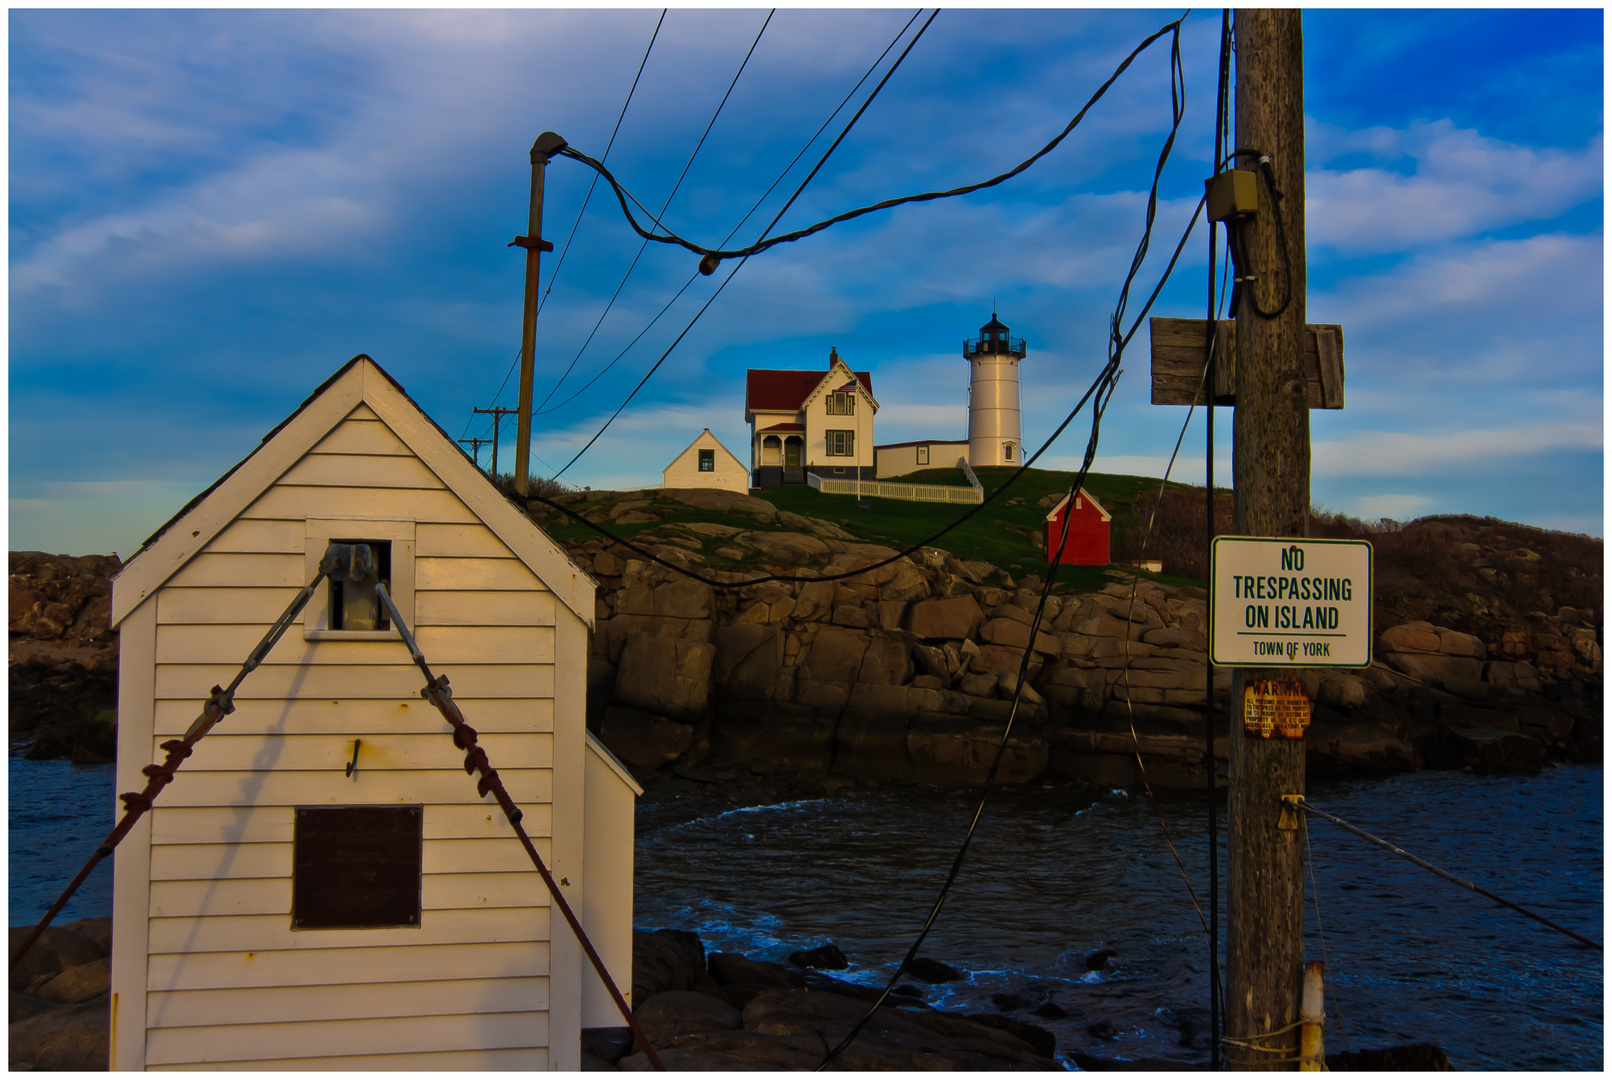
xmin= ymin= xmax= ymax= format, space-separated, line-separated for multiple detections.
xmin=1225 ymin=8 xmax=1311 ymax=1069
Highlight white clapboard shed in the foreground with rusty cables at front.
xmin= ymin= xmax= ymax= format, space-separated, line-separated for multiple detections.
xmin=111 ymin=356 xmax=638 ymax=1070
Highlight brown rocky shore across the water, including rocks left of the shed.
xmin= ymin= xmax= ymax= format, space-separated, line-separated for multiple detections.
xmin=10 ymin=490 xmax=1602 ymax=787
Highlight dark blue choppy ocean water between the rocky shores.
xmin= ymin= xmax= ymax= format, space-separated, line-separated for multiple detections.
xmin=8 ymin=758 xmax=1604 ymax=1070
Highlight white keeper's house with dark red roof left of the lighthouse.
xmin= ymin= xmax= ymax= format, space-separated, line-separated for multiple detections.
xmin=745 ymin=348 xmax=879 ymax=487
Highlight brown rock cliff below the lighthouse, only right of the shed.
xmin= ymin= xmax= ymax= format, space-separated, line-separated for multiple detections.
xmin=551 ymin=492 xmax=1602 ymax=787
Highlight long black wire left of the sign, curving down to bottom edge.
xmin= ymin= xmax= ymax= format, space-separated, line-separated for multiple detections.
xmin=817 ymin=21 xmax=1203 ymax=1072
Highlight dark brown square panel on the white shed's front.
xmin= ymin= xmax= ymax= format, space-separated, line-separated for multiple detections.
xmin=292 ymin=806 xmax=426 ymax=930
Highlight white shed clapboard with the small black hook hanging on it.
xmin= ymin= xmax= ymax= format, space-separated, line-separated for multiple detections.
xmin=152 ymin=724 xmax=555 ymax=779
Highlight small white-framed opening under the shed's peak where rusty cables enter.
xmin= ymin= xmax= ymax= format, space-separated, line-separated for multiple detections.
xmin=303 ymin=517 xmax=414 ymax=642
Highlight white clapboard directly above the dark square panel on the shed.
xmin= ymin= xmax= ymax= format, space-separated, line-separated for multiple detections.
xmin=148 ymin=764 xmax=553 ymax=808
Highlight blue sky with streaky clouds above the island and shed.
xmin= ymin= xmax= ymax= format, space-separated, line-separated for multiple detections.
xmin=6 ymin=8 xmax=1604 ymax=558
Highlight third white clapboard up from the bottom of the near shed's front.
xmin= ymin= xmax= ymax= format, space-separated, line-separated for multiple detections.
xmin=145 ymin=941 xmax=548 ymax=991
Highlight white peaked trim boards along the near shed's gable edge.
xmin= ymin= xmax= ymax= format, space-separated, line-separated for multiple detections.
xmin=111 ymin=353 xmax=596 ymax=627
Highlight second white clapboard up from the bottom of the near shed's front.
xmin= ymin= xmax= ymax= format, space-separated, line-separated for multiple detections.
xmin=147 ymin=975 xmax=548 ymax=1027
